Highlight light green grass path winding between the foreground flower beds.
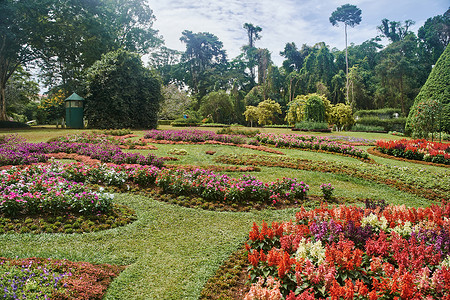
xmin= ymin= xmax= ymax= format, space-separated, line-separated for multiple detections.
xmin=0 ymin=194 xmax=294 ymax=299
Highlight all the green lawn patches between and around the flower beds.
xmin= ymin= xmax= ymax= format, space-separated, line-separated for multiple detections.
xmin=0 ymin=126 xmax=448 ymax=299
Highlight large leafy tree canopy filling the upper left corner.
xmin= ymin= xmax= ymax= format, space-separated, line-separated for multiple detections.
xmin=0 ymin=0 xmax=162 ymax=120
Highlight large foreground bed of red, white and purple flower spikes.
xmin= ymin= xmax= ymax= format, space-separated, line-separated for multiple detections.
xmin=245 ymin=203 xmax=450 ymax=300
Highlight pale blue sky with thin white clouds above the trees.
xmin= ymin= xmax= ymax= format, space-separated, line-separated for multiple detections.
xmin=146 ymin=0 xmax=450 ymax=66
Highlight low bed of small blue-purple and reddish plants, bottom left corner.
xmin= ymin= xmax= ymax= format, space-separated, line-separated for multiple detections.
xmin=0 ymin=258 xmax=124 ymax=300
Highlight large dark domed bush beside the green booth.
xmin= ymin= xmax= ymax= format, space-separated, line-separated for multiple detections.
xmin=86 ymin=50 xmax=161 ymax=129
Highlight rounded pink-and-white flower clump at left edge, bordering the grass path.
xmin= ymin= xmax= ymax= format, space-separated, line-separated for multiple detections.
xmin=0 ymin=165 xmax=113 ymax=216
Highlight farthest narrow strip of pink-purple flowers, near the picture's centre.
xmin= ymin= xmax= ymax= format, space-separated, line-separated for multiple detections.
xmin=144 ymin=129 xmax=247 ymax=144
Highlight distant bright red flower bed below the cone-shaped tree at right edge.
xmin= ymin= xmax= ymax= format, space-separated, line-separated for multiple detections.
xmin=376 ymin=139 xmax=450 ymax=165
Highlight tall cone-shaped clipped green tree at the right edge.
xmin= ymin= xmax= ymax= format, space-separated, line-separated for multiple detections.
xmin=406 ymin=46 xmax=450 ymax=135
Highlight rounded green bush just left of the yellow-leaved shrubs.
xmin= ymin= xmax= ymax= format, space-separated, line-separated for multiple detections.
xmin=200 ymin=91 xmax=234 ymax=124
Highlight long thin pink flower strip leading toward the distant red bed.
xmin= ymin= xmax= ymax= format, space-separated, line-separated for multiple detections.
xmin=256 ymin=133 xmax=369 ymax=159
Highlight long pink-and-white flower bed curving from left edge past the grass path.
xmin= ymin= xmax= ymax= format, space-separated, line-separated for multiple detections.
xmin=0 ymin=162 xmax=309 ymax=209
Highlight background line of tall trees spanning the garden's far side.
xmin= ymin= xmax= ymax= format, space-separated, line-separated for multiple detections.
xmin=0 ymin=0 xmax=450 ymax=131
